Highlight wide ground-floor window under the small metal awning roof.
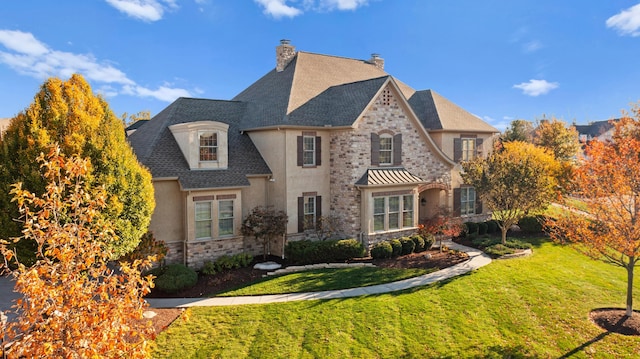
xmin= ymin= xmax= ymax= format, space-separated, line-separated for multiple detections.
xmin=373 ymin=195 xmax=414 ymax=232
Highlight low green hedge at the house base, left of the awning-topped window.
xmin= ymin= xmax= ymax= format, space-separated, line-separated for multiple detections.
xmin=284 ymin=239 xmax=365 ymax=265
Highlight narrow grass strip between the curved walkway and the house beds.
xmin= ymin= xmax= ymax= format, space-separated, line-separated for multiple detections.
xmin=216 ymin=267 xmax=435 ymax=297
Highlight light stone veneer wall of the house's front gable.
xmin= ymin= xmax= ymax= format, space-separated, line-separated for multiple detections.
xmin=330 ymin=86 xmax=451 ymax=241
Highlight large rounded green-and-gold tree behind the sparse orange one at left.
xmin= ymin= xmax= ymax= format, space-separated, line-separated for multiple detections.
xmin=0 ymin=74 xmax=155 ymax=260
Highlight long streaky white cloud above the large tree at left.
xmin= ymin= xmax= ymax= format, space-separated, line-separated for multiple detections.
xmin=0 ymin=30 xmax=190 ymax=102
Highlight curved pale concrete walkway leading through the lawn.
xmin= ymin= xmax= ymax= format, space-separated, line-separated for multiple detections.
xmin=147 ymin=241 xmax=491 ymax=308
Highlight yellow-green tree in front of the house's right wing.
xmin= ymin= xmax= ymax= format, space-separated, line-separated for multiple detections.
xmin=461 ymin=141 xmax=559 ymax=244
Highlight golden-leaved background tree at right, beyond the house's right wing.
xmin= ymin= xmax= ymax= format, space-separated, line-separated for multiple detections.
xmin=533 ymin=118 xmax=580 ymax=162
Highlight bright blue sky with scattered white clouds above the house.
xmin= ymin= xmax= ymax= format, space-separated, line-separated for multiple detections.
xmin=0 ymin=0 xmax=640 ymax=130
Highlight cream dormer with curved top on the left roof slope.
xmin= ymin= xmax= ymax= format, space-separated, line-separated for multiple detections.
xmin=169 ymin=121 xmax=229 ymax=170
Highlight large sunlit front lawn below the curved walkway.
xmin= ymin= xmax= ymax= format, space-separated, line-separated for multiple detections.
xmin=154 ymin=242 xmax=640 ymax=358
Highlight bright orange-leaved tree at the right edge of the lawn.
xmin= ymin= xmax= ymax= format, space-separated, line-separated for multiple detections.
xmin=547 ymin=105 xmax=640 ymax=317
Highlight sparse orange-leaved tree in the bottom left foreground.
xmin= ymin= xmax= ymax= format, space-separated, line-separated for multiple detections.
xmin=0 ymin=147 xmax=152 ymax=358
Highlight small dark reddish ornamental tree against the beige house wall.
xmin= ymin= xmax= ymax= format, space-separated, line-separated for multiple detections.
xmin=241 ymin=206 xmax=289 ymax=259
